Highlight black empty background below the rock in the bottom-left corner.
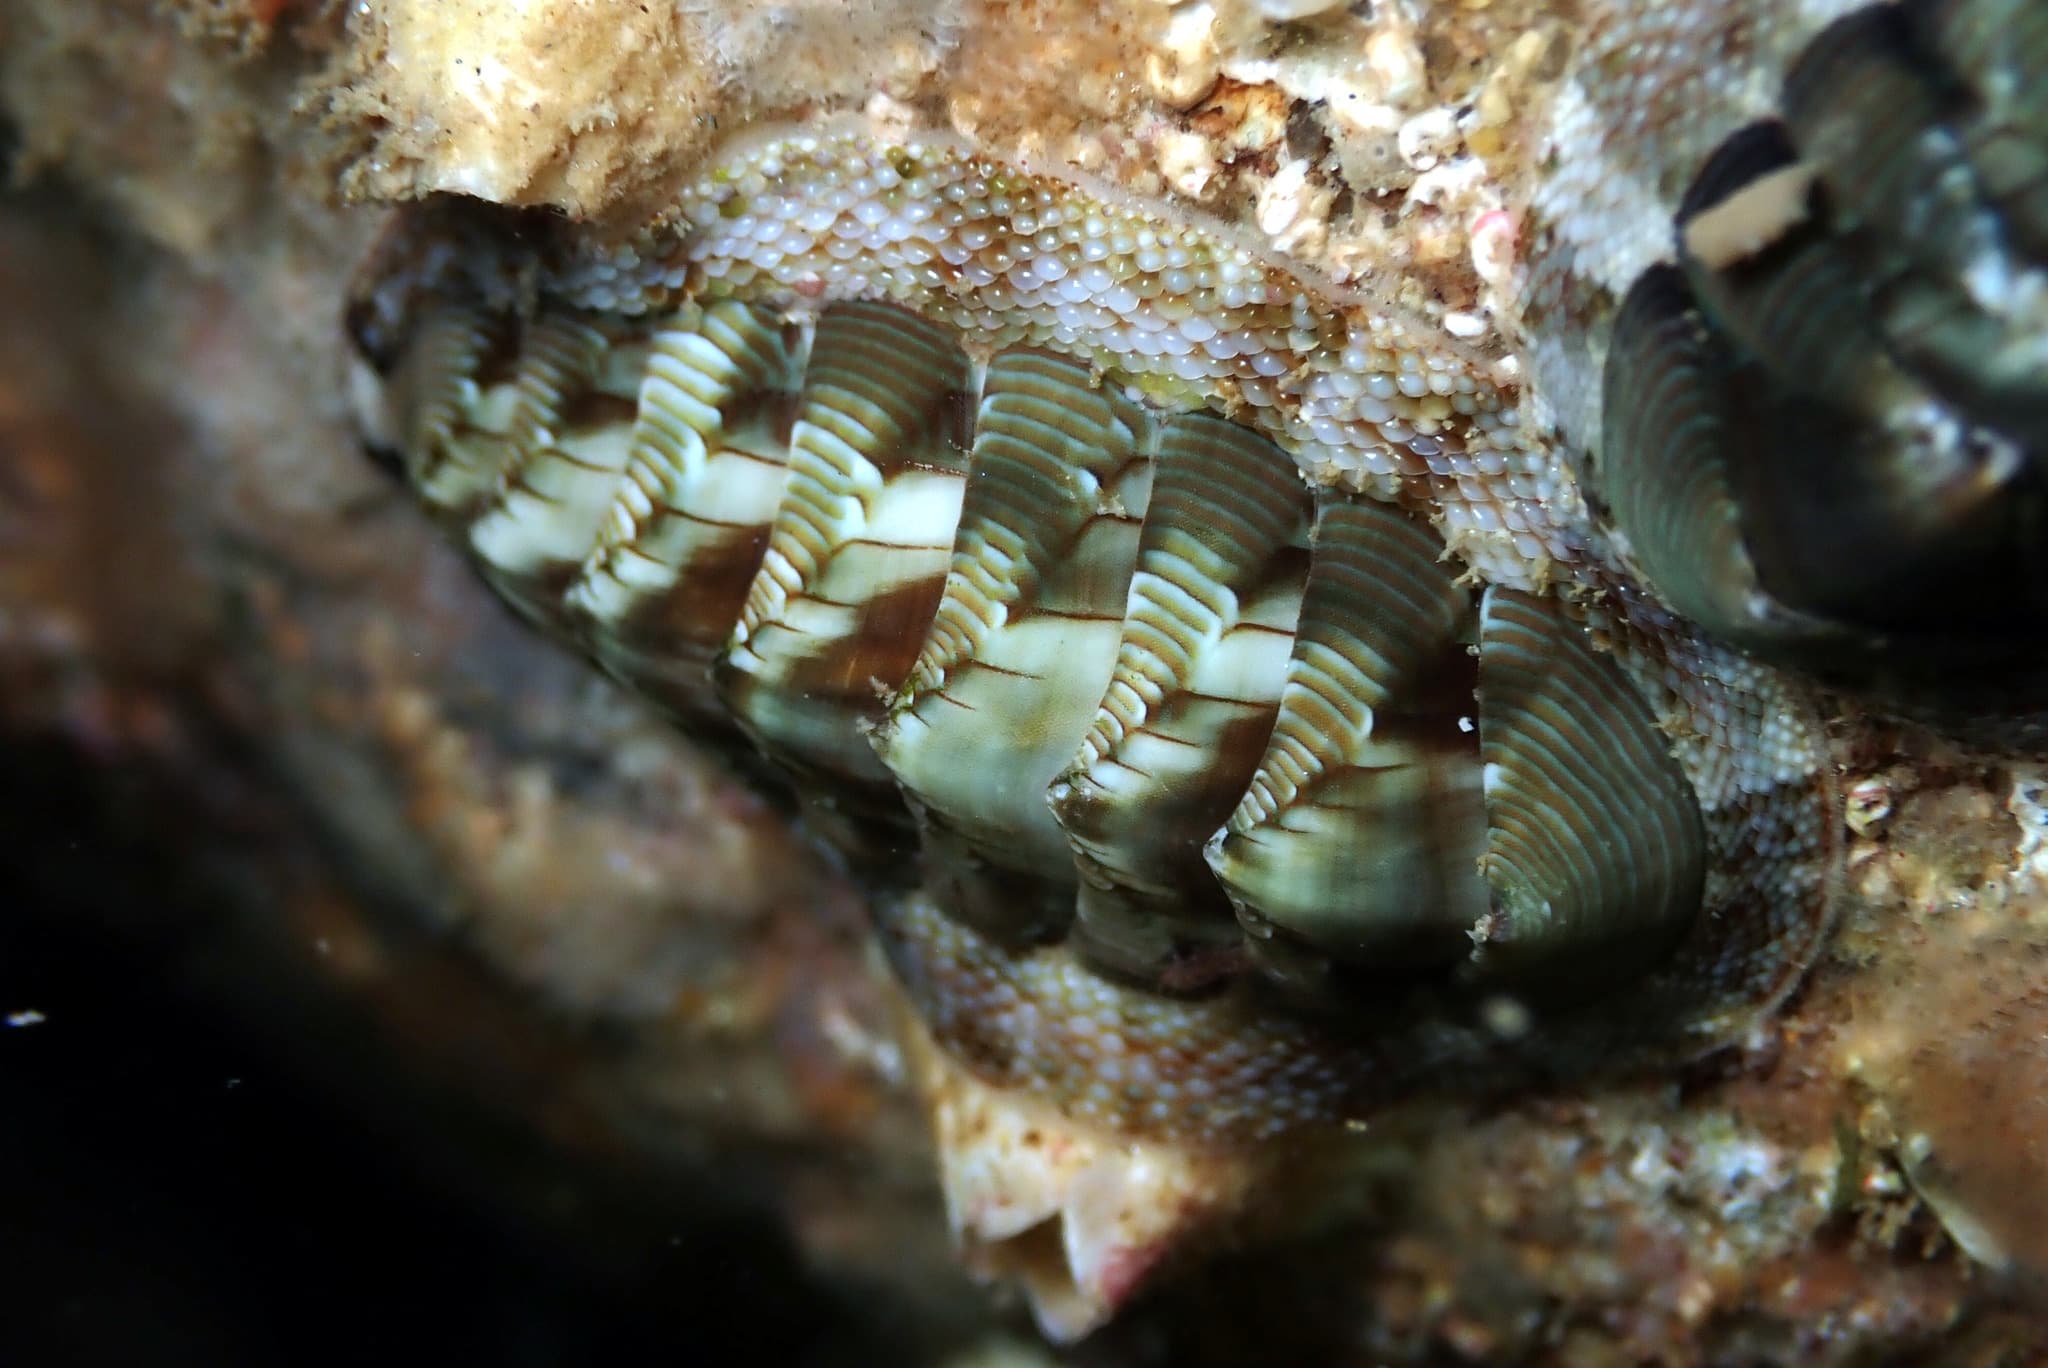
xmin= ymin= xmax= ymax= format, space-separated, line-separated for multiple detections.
xmin=0 ymin=743 xmax=899 ymax=1368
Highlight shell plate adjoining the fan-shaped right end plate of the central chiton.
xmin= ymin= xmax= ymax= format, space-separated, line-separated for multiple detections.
xmin=1208 ymin=496 xmax=1487 ymax=967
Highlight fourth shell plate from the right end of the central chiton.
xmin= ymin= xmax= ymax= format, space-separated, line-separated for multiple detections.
xmin=872 ymin=352 xmax=1151 ymax=887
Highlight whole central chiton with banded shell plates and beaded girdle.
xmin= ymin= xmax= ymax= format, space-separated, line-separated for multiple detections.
xmin=354 ymin=107 xmax=1837 ymax=1147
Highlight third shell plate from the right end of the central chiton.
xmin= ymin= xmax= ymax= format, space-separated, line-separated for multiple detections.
xmin=1053 ymin=414 xmax=1311 ymax=979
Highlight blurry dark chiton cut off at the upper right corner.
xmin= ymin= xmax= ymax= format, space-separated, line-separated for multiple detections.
xmin=1528 ymin=0 xmax=2048 ymax=745
